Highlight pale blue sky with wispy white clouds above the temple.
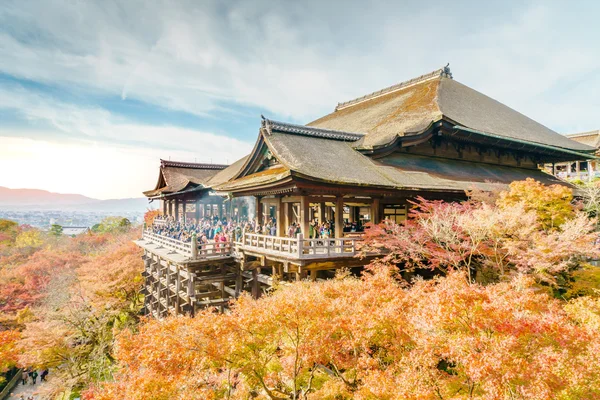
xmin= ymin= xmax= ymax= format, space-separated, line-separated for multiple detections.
xmin=0 ymin=0 xmax=600 ymax=199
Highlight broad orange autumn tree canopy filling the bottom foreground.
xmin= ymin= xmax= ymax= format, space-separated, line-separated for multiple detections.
xmin=85 ymin=266 xmax=600 ymax=400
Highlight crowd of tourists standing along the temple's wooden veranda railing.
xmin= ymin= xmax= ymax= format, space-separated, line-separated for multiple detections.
xmin=151 ymin=216 xmax=363 ymax=244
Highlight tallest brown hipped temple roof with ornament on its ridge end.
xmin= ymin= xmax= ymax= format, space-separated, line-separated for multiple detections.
xmin=308 ymin=69 xmax=592 ymax=151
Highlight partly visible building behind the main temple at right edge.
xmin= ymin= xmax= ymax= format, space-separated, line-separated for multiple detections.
xmin=545 ymin=130 xmax=600 ymax=182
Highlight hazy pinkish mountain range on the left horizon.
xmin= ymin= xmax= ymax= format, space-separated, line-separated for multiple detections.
xmin=0 ymin=186 xmax=157 ymax=212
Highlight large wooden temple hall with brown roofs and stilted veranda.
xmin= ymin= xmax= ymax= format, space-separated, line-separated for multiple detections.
xmin=137 ymin=67 xmax=596 ymax=318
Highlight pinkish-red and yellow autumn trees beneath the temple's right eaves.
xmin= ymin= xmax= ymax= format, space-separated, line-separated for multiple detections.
xmin=365 ymin=180 xmax=598 ymax=286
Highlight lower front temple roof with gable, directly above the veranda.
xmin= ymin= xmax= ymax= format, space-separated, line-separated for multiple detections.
xmin=215 ymin=120 xmax=576 ymax=193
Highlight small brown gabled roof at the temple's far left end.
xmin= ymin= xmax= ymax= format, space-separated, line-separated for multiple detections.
xmin=144 ymin=159 xmax=227 ymax=198
